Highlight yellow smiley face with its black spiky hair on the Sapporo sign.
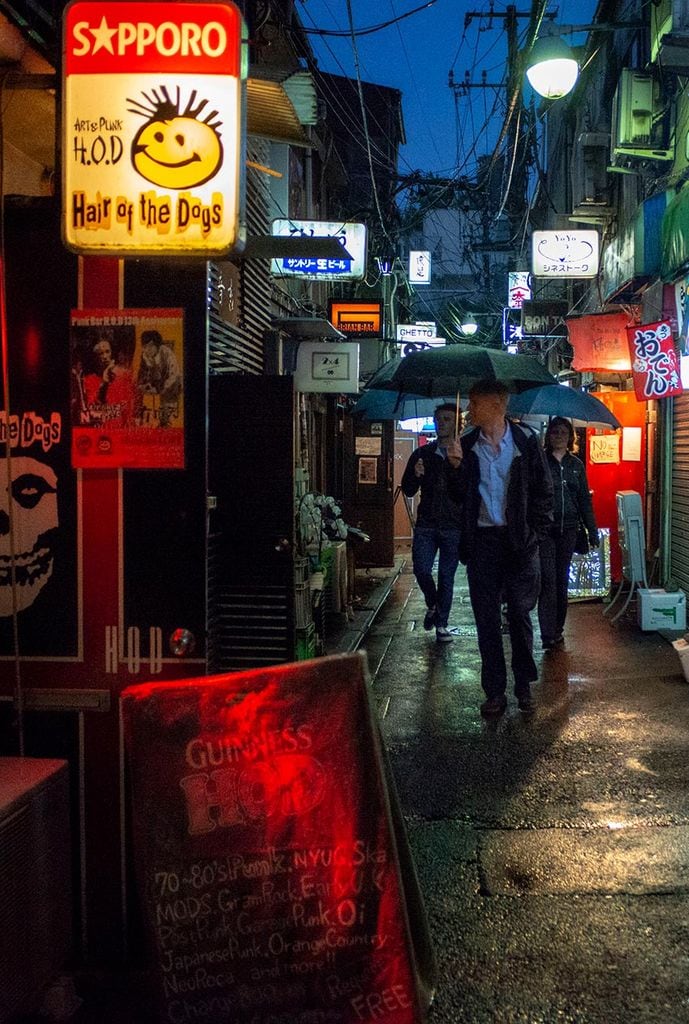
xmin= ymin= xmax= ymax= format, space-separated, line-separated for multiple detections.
xmin=127 ymin=86 xmax=223 ymax=188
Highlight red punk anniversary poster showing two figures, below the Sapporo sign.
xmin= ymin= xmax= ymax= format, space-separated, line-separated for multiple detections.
xmin=71 ymin=309 xmax=184 ymax=469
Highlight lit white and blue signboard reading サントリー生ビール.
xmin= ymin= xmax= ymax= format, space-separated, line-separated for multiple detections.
xmin=270 ymin=218 xmax=367 ymax=281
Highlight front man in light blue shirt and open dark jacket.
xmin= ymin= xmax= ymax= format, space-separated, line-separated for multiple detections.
xmin=446 ymin=381 xmax=553 ymax=718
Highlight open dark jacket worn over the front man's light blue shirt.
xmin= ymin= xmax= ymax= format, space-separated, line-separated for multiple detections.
xmin=447 ymin=421 xmax=553 ymax=564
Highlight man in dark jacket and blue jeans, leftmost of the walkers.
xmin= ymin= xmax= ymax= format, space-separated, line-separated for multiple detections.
xmin=400 ymin=403 xmax=460 ymax=643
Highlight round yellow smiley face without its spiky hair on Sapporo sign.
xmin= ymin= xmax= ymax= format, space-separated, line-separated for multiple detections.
xmin=131 ymin=115 xmax=222 ymax=188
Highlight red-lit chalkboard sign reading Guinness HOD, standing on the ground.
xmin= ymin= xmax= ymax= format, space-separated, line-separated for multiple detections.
xmin=122 ymin=654 xmax=434 ymax=1024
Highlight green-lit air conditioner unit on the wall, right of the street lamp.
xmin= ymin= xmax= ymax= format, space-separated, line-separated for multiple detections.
xmin=611 ymin=68 xmax=675 ymax=165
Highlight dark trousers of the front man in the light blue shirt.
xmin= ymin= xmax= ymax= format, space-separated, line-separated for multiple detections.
xmin=467 ymin=526 xmax=541 ymax=697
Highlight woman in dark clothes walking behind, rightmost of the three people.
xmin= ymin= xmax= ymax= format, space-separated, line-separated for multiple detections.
xmin=539 ymin=416 xmax=599 ymax=650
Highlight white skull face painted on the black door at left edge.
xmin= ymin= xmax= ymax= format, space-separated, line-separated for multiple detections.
xmin=0 ymin=456 xmax=59 ymax=617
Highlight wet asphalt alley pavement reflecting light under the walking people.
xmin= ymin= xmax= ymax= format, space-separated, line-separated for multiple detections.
xmin=363 ymin=563 xmax=689 ymax=1024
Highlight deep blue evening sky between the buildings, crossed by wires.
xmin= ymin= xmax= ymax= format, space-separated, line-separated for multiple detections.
xmin=297 ymin=0 xmax=597 ymax=175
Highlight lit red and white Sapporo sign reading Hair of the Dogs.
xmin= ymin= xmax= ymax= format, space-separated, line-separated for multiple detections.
xmin=62 ymin=0 xmax=245 ymax=256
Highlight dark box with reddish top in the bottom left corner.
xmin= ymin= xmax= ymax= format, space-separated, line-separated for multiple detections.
xmin=0 ymin=758 xmax=73 ymax=1024
